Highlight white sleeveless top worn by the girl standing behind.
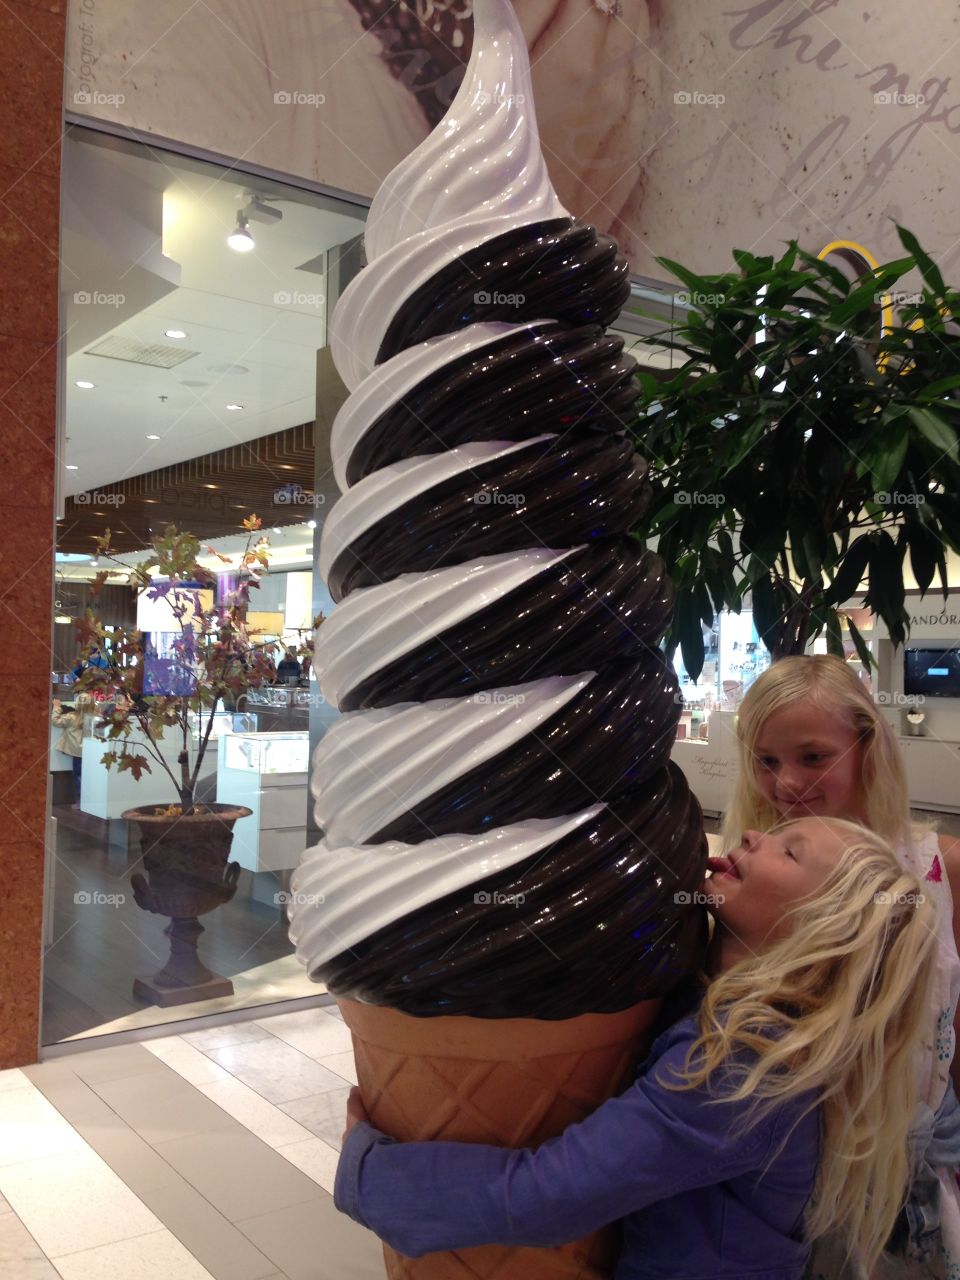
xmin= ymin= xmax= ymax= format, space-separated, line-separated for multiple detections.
xmin=897 ymin=831 xmax=960 ymax=1280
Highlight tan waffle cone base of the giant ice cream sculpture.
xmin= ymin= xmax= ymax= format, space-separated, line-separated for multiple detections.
xmin=337 ymin=1000 xmax=660 ymax=1280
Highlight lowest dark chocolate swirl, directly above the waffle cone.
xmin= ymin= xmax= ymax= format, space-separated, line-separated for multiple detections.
xmin=314 ymin=763 xmax=707 ymax=1019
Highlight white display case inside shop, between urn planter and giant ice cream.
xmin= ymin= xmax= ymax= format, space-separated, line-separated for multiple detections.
xmin=216 ymin=733 xmax=310 ymax=872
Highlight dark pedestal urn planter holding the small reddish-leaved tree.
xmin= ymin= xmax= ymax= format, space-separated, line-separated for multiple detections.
xmin=123 ymin=804 xmax=252 ymax=1007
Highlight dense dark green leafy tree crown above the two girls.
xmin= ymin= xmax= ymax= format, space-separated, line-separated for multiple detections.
xmin=635 ymin=228 xmax=960 ymax=680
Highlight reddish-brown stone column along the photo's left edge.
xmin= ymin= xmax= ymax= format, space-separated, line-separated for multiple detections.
xmin=0 ymin=0 xmax=67 ymax=1068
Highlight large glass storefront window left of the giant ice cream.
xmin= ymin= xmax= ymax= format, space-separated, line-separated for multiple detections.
xmin=42 ymin=127 xmax=365 ymax=1044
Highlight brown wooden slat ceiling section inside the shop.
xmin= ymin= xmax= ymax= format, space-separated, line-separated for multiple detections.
xmin=56 ymin=422 xmax=316 ymax=553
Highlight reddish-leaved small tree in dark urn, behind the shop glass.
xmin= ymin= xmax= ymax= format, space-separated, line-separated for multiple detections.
xmin=77 ymin=516 xmax=293 ymax=1006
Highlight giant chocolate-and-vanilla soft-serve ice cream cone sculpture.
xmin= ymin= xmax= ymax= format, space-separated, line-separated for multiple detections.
xmin=292 ymin=0 xmax=705 ymax=1280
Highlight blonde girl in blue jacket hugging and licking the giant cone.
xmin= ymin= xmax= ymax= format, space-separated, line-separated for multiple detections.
xmin=334 ymin=818 xmax=938 ymax=1280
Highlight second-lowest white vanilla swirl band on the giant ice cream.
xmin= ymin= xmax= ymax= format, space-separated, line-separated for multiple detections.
xmin=312 ymin=671 xmax=595 ymax=849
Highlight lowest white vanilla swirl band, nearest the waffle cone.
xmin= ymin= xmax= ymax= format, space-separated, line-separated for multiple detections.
xmin=289 ymin=804 xmax=605 ymax=975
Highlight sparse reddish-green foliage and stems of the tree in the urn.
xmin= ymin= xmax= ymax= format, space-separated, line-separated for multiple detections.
xmin=77 ymin=516 xmax=316 ymax=817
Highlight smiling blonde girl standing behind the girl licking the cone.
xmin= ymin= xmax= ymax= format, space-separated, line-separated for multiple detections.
xmin=723 ymin=654 xmax=960 ymax=1280
